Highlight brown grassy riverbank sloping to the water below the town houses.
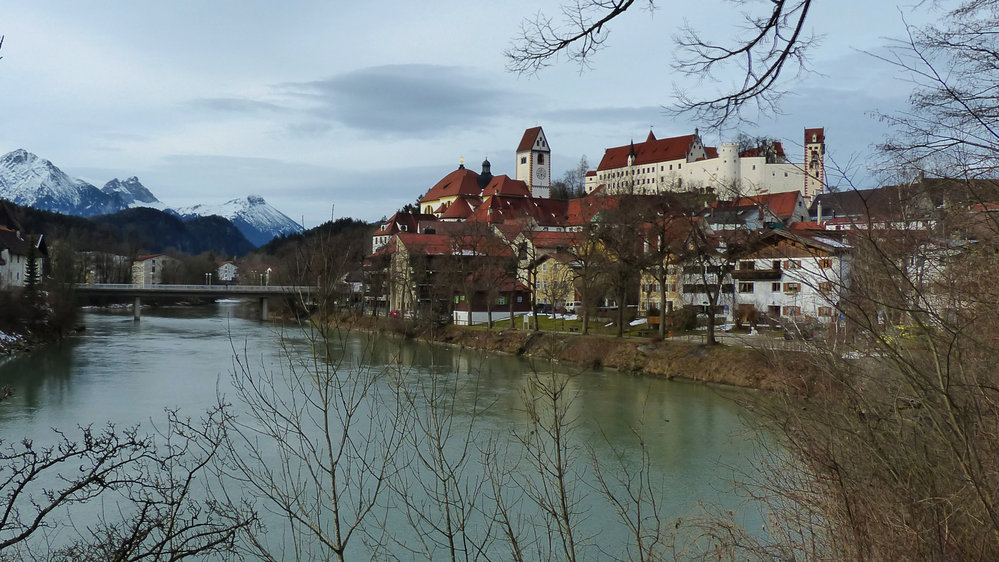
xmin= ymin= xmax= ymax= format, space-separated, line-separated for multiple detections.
xmin=348 ymin=318 xmax=809 ymax=393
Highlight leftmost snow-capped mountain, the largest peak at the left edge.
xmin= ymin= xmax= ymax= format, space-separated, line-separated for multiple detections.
xmin=0 ymin=149 xmax=118 ymax=217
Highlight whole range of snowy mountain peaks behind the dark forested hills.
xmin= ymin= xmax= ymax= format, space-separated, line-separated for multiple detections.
xmin=0 ymin=149 xmax=302 ymax=246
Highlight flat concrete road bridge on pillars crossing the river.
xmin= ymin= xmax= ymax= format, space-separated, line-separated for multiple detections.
xmin=73 ymin=283 xmax=319 ymax=320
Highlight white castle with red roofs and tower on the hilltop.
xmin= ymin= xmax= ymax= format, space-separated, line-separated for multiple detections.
xmin=586 ymin=128 xmax=825 ymax=204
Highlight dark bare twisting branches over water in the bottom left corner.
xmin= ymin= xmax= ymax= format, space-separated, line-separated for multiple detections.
xmin=0 ymin=411 xmax=257 ymax=561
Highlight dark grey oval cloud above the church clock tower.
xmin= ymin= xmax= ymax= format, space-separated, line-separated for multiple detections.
xmin=280 ymin=64 xmax=517 ymax=137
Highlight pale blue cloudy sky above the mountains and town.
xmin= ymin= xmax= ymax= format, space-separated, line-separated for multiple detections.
xmin=0 ymin=0 xmax=932 ymax=228
